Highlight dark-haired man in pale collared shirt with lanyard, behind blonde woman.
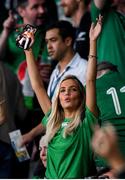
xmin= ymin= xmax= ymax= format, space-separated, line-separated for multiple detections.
xmin=20 ymin=21 xmax=87 ymax=146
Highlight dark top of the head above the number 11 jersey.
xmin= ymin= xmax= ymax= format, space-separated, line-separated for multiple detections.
xmin=97 ymin=61 xmax=118 ymax=71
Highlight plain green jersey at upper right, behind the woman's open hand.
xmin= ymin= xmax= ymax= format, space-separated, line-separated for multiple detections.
xmin=91 ymin=0 xmax=125 ymax=78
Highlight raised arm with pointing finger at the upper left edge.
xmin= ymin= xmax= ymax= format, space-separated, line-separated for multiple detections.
xmin=0 ymin=11 xmax=15 ymax=58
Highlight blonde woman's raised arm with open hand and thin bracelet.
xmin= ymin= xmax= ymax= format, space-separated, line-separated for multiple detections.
xmin=86 ymin=16 xmax=102 ymax=116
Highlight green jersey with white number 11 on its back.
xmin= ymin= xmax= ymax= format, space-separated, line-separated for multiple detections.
xmin=96 ymin=71 xmax=125 ymax=167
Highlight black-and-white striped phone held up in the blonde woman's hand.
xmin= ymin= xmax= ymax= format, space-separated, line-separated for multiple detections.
xmin=16 ymin=24 xmax=37 ymax=50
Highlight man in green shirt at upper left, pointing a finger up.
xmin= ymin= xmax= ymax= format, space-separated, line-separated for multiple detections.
xmin=0 ymin=0 xmax=56 ymax=109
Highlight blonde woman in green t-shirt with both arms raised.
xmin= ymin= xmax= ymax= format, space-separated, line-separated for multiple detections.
xmin=25 ymin=16 xmax=102 ymax=179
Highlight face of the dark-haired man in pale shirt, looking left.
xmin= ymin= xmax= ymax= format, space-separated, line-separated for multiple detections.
xmin=45 ymin=28 xmax=67 ymax=61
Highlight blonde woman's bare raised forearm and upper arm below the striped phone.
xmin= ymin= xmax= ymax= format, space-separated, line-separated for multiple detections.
xmin=25 ymin=49 xmax=51 ymax=114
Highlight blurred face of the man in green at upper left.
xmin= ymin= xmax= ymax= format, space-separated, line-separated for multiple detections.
xmin=19 ymin=0 xmax=47 ymax=26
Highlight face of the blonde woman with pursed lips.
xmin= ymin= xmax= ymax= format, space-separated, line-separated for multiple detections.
xmin=59 ymin=79 xmax=81 ymax=110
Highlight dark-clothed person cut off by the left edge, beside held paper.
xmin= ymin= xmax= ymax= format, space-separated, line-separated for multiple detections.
xmin=0 ymin=62 xmax=28 ymax=179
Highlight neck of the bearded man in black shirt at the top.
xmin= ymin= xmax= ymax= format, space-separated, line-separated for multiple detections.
xmin=72 ymin=4 xmax=87 ymax=27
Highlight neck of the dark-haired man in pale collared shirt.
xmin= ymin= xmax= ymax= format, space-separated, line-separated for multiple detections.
xmin=59 ymin=51 xmax=74 ymax=73
